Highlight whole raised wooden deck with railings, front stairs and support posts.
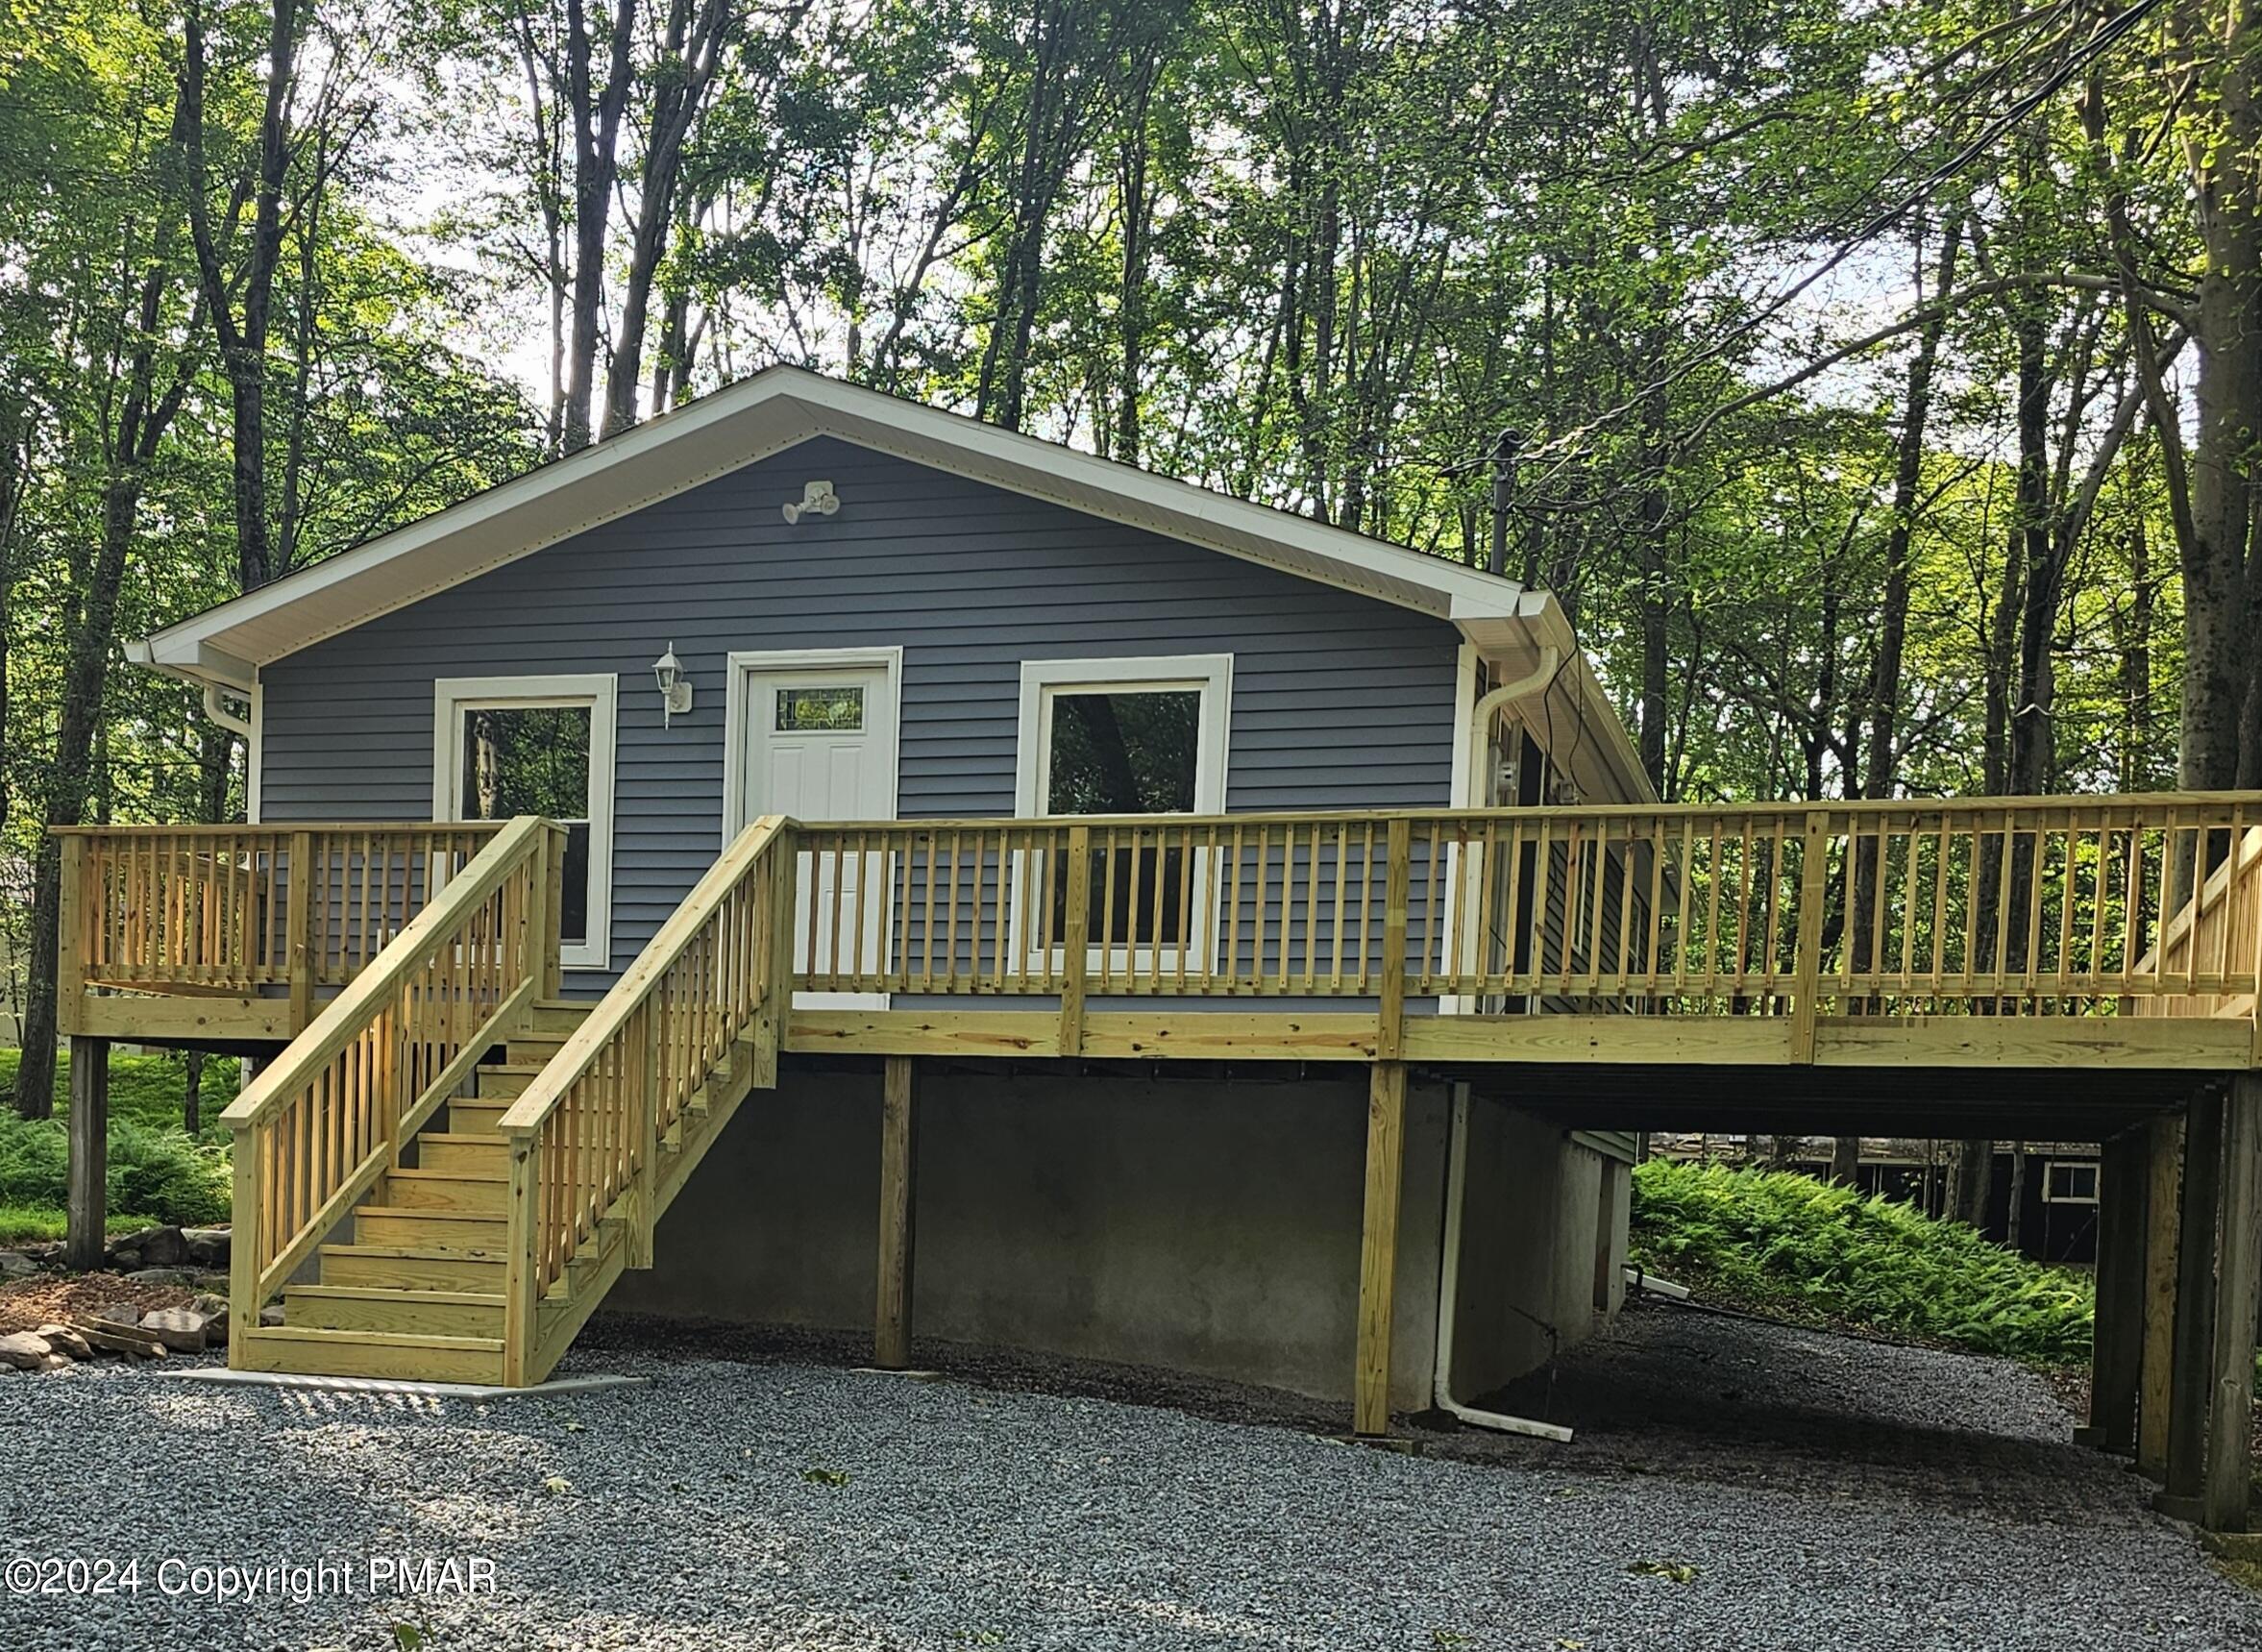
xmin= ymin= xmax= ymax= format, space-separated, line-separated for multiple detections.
xmin=39 ymin=795 xmax=2262 ymax=1527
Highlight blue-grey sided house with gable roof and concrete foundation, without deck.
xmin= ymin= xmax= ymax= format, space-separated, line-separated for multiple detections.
xmin=101 ymin=369 xmax=1647 ymax=1408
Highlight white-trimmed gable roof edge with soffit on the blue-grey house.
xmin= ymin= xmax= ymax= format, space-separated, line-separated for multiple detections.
xmin=127 ymin=366 xmax=1637 ymax=796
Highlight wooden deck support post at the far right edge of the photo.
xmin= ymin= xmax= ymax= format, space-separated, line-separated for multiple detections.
xmin=2199 ymin=1073 xmax=2262 ymax=1532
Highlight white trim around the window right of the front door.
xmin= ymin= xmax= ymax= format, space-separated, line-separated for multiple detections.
xmin=1014 ymin=654 xmax=1233 ymax=969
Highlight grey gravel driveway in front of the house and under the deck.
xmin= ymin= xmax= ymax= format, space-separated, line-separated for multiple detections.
xmin=0 ymin=1310 xmax=2262 ymax=1652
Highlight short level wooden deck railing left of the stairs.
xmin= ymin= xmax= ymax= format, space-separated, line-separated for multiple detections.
xmin=61 ymin=824 xmax=503 ymax=1025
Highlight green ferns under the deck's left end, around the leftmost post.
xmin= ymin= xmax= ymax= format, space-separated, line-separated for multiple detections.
xmin=0 ymin=1050 xmax=237 ymax=1245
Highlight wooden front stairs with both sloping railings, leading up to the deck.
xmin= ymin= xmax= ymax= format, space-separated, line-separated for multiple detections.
xmin=224 ymin=817 xmax=794 ymax=1387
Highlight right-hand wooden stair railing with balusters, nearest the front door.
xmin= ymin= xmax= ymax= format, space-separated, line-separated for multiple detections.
xmin=496 ymin=815 xmax=799 ymax=1385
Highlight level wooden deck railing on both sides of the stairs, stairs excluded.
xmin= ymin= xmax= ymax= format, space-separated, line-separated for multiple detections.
xmin=63 ymin=795 xmax=2262 ymax=1071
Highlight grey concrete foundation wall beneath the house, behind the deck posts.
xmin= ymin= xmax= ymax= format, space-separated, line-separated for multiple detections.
xmin=608 ymin=1066 xmax=1599 ymax=1410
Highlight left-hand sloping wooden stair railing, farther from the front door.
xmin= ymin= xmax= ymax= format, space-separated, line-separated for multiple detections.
xmin=219 ymin=815 xmax=566 ymax=1363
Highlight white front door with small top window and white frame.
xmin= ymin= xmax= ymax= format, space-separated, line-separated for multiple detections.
xmin=740 ymin=663 xmax=896 ymax=1009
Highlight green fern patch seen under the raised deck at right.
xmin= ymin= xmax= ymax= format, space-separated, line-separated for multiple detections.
xmin=1634 ymin=1159 xmax=2095 ymax=1365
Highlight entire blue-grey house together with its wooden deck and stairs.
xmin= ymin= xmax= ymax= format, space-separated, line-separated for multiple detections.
xmin=59 ymin=369 xmax=2262 ymax=1523
